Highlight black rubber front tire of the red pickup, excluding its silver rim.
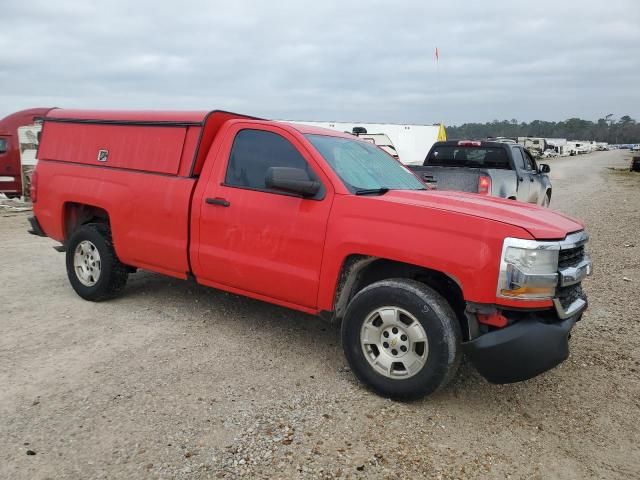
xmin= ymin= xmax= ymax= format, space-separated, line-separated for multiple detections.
xmin=342 ymin=278 xmax=462 ymax=400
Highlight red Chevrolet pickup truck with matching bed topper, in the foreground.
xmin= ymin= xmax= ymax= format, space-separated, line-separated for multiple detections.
xmin=30 ymin=110 xmax=591 ymax=398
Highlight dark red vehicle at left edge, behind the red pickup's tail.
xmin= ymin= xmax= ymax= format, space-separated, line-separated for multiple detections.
xmin=0 ymin=108 xmax=51 ymax=197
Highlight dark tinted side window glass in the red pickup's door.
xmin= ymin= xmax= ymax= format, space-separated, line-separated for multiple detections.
xmin=224 ymin=130 xmax=317 ymax=190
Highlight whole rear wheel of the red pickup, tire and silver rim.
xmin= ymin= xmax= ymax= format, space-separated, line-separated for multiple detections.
xmin=66 ymin=223 xmax=129 ymax=302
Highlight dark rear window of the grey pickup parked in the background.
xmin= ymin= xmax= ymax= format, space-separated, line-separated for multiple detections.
xmin=424 ymin=145 xmax=510 ymax=169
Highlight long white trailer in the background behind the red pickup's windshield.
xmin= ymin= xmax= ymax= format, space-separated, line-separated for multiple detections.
xmin=285 ymin=120 xmax=447 ymax=165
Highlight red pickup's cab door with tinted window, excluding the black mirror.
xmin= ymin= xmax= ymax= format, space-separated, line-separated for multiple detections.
xmin=195 ymin=124 xmax=333 ymax=308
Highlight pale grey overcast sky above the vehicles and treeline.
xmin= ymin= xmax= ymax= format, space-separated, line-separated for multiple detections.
xmin=0 ymin=0 xmax=640 ymax=124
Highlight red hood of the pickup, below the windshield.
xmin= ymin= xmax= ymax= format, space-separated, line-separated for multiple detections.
xmin=378 ymin=190 xmax=584 ymax=240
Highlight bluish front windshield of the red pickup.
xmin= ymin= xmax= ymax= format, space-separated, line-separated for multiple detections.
xmin=305 ymin=134 xmax=426 ymax=194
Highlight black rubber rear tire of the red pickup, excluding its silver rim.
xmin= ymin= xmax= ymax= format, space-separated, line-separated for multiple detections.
xmin=66 ymin=223 xmax=129 ymax=302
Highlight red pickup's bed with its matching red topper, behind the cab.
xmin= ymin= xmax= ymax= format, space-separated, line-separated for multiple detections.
xmin=33 ymin=110 xmax=258 ymax=278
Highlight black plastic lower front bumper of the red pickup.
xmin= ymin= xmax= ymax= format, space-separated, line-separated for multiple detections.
xmin=462 ymin=315 xmax=580 ymax=383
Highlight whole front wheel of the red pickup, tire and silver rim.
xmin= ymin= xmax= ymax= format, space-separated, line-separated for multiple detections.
xmin=342 ymin=279 xmax=461 ymax=399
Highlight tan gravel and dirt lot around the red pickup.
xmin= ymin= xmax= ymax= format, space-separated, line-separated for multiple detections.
xmin=0 ymin=152 xmax=640 ymax=479
